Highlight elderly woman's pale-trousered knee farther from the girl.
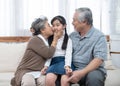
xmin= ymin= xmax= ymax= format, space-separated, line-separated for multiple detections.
xmin=21 ymin=74 xmax=36 ymax=86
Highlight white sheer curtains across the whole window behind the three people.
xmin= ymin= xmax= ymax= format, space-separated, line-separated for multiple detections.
xmin=0 ymin=0 xmax=120 ymax=36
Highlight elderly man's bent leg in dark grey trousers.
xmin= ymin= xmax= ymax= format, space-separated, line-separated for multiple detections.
xmin=85 ymin=70 xmax=105 ymax=86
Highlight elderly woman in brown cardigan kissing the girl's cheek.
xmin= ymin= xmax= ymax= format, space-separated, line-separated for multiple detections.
xmin=11 ymin=16 xmax=61 ymax=86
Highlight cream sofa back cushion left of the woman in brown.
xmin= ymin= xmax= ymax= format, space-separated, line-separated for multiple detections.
xmin=0 ymin=42 xmax=27 ymax=72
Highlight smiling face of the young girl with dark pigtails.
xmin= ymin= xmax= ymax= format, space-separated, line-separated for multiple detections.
xmin=52 ymin=20 xmax=66 ymax=31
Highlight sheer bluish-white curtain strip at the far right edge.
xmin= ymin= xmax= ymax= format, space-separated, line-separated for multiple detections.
xmin=110 ymin=0 xmax=120 ymax=35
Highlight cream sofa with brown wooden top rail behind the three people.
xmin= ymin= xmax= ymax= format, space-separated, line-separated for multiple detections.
xmin=0 ymin=36 xmax=120 ymax=86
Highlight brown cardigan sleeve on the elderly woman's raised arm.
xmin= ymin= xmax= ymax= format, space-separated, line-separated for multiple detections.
xmin=28 ymin=36 xmax=55 ymax=59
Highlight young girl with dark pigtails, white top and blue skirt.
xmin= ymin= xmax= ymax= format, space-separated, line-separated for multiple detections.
xmin=42 ymin=16 xmax=74 ymax=86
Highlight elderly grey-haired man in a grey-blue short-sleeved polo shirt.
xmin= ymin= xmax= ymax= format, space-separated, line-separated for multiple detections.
xmin=68 ymin=8 xmax=107 ymax=86
